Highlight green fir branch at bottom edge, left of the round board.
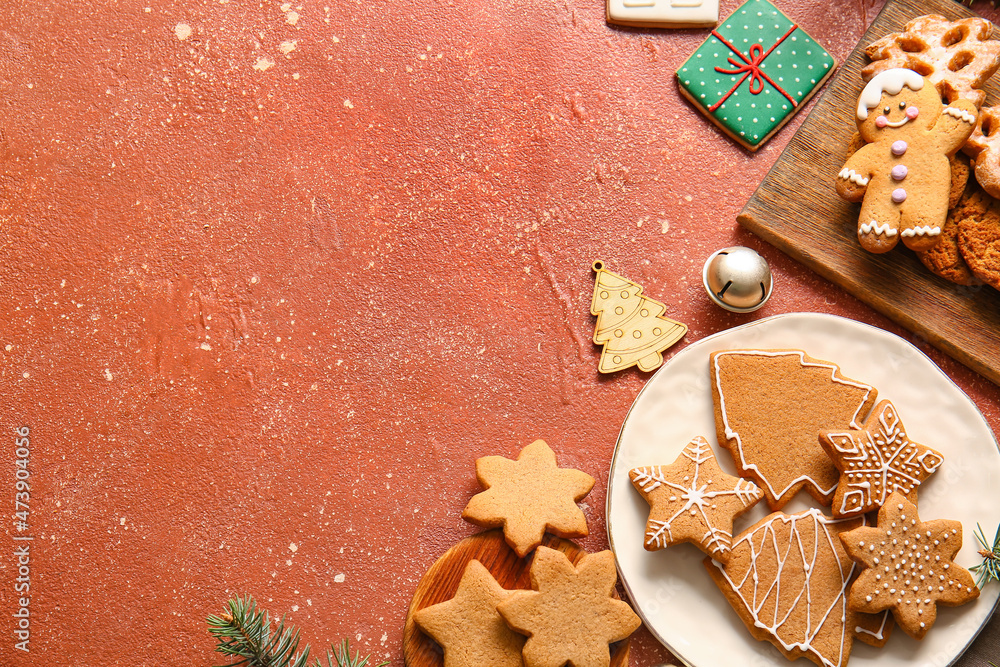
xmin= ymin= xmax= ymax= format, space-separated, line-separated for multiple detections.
xmin=207 ymin=595 xmax=389 ymax=667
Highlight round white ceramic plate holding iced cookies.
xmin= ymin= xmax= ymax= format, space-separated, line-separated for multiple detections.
xmin=607 ymin=313 xmax=1000 ymax=667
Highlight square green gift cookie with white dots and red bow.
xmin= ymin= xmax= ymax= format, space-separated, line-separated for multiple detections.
xmin=677 ymin=0 xmax=836 ymax=150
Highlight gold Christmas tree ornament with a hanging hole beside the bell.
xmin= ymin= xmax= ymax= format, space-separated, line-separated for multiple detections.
xmin=590 ymin=260 xmax=687 ymax=373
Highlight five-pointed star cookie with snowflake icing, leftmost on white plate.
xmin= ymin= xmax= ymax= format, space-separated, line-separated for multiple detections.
xmin=628 ymin=436 xmax=764 ymax=563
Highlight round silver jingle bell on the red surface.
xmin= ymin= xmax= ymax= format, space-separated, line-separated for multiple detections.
xmin=701 ymin=246 xmax=773 ymax=313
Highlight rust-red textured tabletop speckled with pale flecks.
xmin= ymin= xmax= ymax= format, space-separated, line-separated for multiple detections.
xmin=0 ymin=0 xmax=1000 ymax=666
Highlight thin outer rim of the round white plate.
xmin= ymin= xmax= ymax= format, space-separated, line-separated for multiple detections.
xmin=604 ymin=311 xmax=1000 ymax=667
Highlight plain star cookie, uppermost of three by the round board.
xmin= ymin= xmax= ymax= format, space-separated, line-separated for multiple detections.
xmin=462 ymin=440 xmax=594 ymax=557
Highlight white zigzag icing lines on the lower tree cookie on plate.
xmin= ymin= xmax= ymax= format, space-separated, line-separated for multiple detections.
xmin=712 ymin=508 xmax=867 ymax=667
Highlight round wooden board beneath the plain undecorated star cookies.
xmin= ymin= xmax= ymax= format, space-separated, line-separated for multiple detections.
xmin=403 ymin=529 xmax=629 ymax=667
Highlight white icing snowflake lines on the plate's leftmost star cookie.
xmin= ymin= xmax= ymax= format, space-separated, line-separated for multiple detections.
xmin=633 ymin=437 xmax=761 ymax=554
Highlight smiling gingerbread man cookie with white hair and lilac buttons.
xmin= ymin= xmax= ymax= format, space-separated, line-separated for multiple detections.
xmin=836 ymin=68 xmax=978 ymax=253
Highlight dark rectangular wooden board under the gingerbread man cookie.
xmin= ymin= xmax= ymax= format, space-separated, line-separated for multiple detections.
xmin=737 ymin=0 xmax=1000 ymax=384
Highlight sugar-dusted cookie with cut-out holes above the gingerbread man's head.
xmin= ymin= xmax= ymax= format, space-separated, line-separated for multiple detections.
xmin=861 ymin=14 xmax=1000 ymax=107
